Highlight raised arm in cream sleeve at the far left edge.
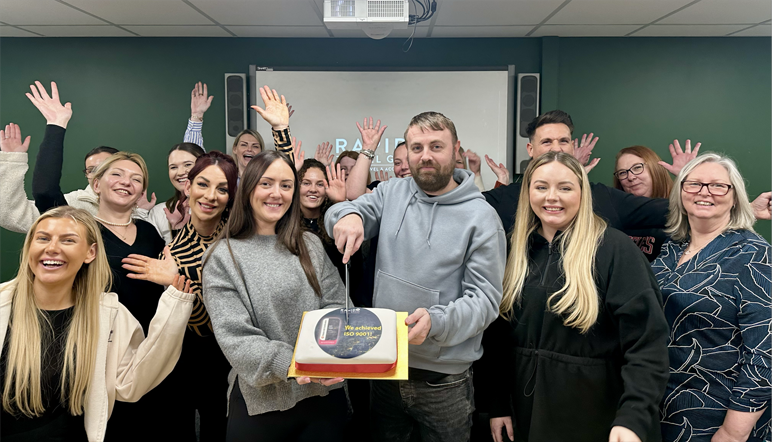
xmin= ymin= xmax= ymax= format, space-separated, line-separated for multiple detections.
xmin=0 ymin=123 xmax=40 ymax=233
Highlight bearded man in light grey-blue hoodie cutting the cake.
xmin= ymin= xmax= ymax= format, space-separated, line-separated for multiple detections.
xmin=325 ymin=112 xmax=506 ymax=442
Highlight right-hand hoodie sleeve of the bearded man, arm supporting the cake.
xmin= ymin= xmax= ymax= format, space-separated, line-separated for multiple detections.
xmin=427 ymin=226 xmax=507 ymax=347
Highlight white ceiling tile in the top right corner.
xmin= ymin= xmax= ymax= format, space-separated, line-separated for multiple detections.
xmin=657 ymin=0 xmax=772 ymax=24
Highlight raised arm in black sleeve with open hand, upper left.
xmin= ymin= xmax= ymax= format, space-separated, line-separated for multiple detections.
xmin=26 ymin=81 xmax=72 ymax=213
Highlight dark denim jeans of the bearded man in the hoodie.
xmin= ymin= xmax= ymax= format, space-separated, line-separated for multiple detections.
xmin=370 ymin=369 xmax=474 ymax=442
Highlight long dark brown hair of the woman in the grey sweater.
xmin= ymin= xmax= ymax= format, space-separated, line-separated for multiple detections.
xmin=220 ymin=150 xmax=322 ymax=298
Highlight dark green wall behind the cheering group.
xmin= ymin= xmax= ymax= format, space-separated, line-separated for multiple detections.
xmin=0 ymin=37 xmax=772 ymax=280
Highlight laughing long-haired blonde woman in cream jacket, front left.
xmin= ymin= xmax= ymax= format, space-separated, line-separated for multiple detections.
xmin=0 ymin=207 xmax=193 ymax=441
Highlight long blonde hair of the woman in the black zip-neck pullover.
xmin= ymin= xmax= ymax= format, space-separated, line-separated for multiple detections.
xmin=499 ymin=152 xmax=606 ymax=333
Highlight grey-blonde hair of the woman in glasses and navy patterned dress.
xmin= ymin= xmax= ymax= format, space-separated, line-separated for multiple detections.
xmin=665 ymin=153 xmax=756 ymax=241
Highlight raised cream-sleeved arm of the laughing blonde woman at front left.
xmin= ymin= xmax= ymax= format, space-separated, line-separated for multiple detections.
xmin=114 ymin=275 xmax=194 ymax=402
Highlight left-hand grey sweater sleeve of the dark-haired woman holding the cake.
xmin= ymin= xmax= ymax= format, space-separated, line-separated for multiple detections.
xmin=202 ymin=243 xmax=293 ymax=387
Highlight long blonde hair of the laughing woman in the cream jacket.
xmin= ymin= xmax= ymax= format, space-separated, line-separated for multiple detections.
xmin=3 ymin=206 xmax=112 ymax=417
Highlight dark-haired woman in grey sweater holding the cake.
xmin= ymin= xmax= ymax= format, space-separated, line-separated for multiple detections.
xmin=203 ymin=151 xmax=348 ymax=441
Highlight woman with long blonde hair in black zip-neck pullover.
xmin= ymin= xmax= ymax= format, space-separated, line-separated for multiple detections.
xmin=477 ymin=152 xmax=668 ymax=442
